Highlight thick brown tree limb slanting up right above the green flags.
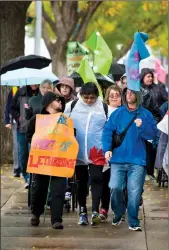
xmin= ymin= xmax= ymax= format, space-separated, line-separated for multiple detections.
xmin=72 ymin=1 xmax=103 ymax=42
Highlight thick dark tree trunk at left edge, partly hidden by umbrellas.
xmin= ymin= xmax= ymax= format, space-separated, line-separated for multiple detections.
xmin=0 ymin=1 xmax=31 ymax=163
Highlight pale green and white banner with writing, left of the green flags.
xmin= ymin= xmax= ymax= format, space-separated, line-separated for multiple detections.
xmin=66 ymin=42 xmax=88 ymax=75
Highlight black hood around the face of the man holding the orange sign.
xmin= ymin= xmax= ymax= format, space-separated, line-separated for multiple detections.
xmin=41 ymin=91 xmax=65 ymax=114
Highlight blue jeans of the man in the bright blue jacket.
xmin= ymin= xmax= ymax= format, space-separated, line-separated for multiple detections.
xmin=109 ymin=164 xmax=146 ymax=227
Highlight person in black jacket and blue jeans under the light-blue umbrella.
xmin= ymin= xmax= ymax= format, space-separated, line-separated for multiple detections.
xmin=11 ymin=85 xmax=39 ymax=188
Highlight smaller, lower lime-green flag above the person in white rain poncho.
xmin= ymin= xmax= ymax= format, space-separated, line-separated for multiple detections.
xmin=77 ymin=56 xmax=103 ymax=99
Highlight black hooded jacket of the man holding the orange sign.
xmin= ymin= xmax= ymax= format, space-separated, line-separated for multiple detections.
xmin=26 ymin=92 xmax=65 ymax=143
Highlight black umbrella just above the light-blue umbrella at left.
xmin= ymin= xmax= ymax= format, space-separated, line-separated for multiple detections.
xmin=0 ymin=55 xmax=52 ymax=75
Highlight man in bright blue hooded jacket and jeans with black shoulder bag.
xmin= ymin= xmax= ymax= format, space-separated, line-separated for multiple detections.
xmin=102 ymin=89 xmax=157 ymax=231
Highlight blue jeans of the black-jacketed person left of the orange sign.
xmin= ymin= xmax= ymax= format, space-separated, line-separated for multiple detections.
xmin=17 ymin=131 xmax=29 ymax=182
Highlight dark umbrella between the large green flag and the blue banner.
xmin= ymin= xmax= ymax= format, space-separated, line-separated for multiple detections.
xmin=109 ymin=63 xmax=126 ymax=81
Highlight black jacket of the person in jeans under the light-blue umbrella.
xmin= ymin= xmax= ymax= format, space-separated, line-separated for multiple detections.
xmin=11 ymin=86 xmax=39 ymax=133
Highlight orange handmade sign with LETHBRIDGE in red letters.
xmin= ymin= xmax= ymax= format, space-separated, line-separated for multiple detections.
xmin=27 ymin=113 xmax=79 ymax=178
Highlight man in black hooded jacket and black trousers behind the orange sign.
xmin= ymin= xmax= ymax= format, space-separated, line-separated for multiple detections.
xmin=26 ymin=92 xmax=66 ymax=229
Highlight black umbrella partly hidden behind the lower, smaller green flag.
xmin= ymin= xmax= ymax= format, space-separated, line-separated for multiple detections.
xmin=70 ymin=72 xmax=114 ymax=89
